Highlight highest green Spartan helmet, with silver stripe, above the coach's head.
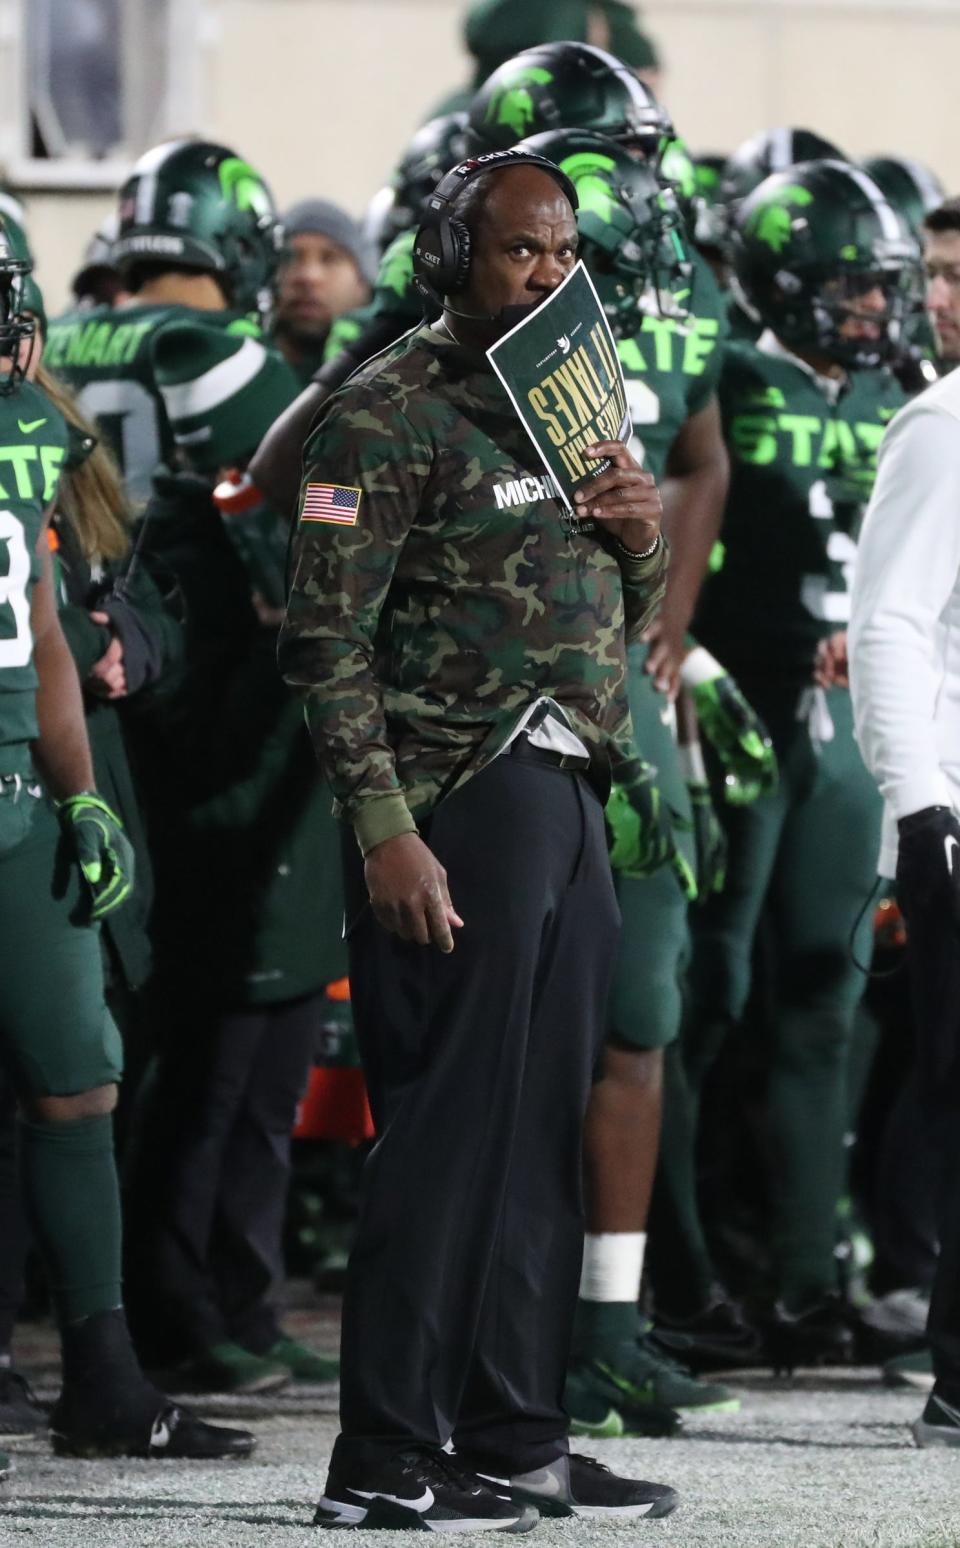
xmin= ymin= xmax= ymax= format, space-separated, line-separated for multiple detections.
xmin=466 ymin=43 xmax=672 ymax=164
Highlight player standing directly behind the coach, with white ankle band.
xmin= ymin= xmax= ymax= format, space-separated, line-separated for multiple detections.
xmin=510 ymin=117 xmax=771 ymax=1435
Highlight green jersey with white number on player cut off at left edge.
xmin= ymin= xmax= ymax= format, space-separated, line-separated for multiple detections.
xmin=0 ymin=382 xmax=68 ymax=755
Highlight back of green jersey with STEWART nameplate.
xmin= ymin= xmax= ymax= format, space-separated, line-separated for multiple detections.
xmin=43 ymin=295 xmax=255 ymax=506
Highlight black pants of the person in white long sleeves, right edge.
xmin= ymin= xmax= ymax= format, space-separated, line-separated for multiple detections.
xmin=897 ymin=878 xmax=960 ymax=1406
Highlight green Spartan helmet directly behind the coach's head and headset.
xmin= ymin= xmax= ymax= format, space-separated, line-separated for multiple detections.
xmin=516 ymin=128 xmax=691 ymax=337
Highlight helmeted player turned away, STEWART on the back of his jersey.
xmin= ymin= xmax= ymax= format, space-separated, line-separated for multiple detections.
xmin=45 ymin=139 xmax=279 ymax=508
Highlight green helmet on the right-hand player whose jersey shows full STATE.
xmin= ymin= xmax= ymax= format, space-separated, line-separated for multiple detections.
xmin=731 ymin=161 xmax=920 ymax=367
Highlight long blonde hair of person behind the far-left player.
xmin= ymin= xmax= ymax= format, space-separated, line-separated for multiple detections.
xmin=36 ymin=364 xmax=130 ymax=560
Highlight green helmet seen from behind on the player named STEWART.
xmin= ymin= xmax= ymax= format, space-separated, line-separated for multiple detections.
xmin=111 ymin=139 xmax=280 ymax=311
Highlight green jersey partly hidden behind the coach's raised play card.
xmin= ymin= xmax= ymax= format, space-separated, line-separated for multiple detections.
xmin=593 ymin=257 xmax=726 ymax=478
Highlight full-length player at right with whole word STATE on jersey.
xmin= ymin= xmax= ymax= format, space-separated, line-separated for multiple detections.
xmin=668 ymin=159 xmax=917 ymax=1367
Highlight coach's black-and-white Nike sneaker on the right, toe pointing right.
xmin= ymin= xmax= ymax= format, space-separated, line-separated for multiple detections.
xmin=480 ymin=1452 xmax=680 ymax=1520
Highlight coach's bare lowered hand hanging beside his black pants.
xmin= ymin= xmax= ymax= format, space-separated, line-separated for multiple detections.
xmin=364 ymin=833 xmax=463 ymax=952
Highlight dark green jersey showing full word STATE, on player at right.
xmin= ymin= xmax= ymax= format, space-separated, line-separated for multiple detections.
xmin=694 ymin=334 xmax=906 ymax=683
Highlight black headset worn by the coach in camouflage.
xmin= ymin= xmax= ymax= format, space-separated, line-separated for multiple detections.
xmin=413 ymin=150 xmax=578 ymax=300
